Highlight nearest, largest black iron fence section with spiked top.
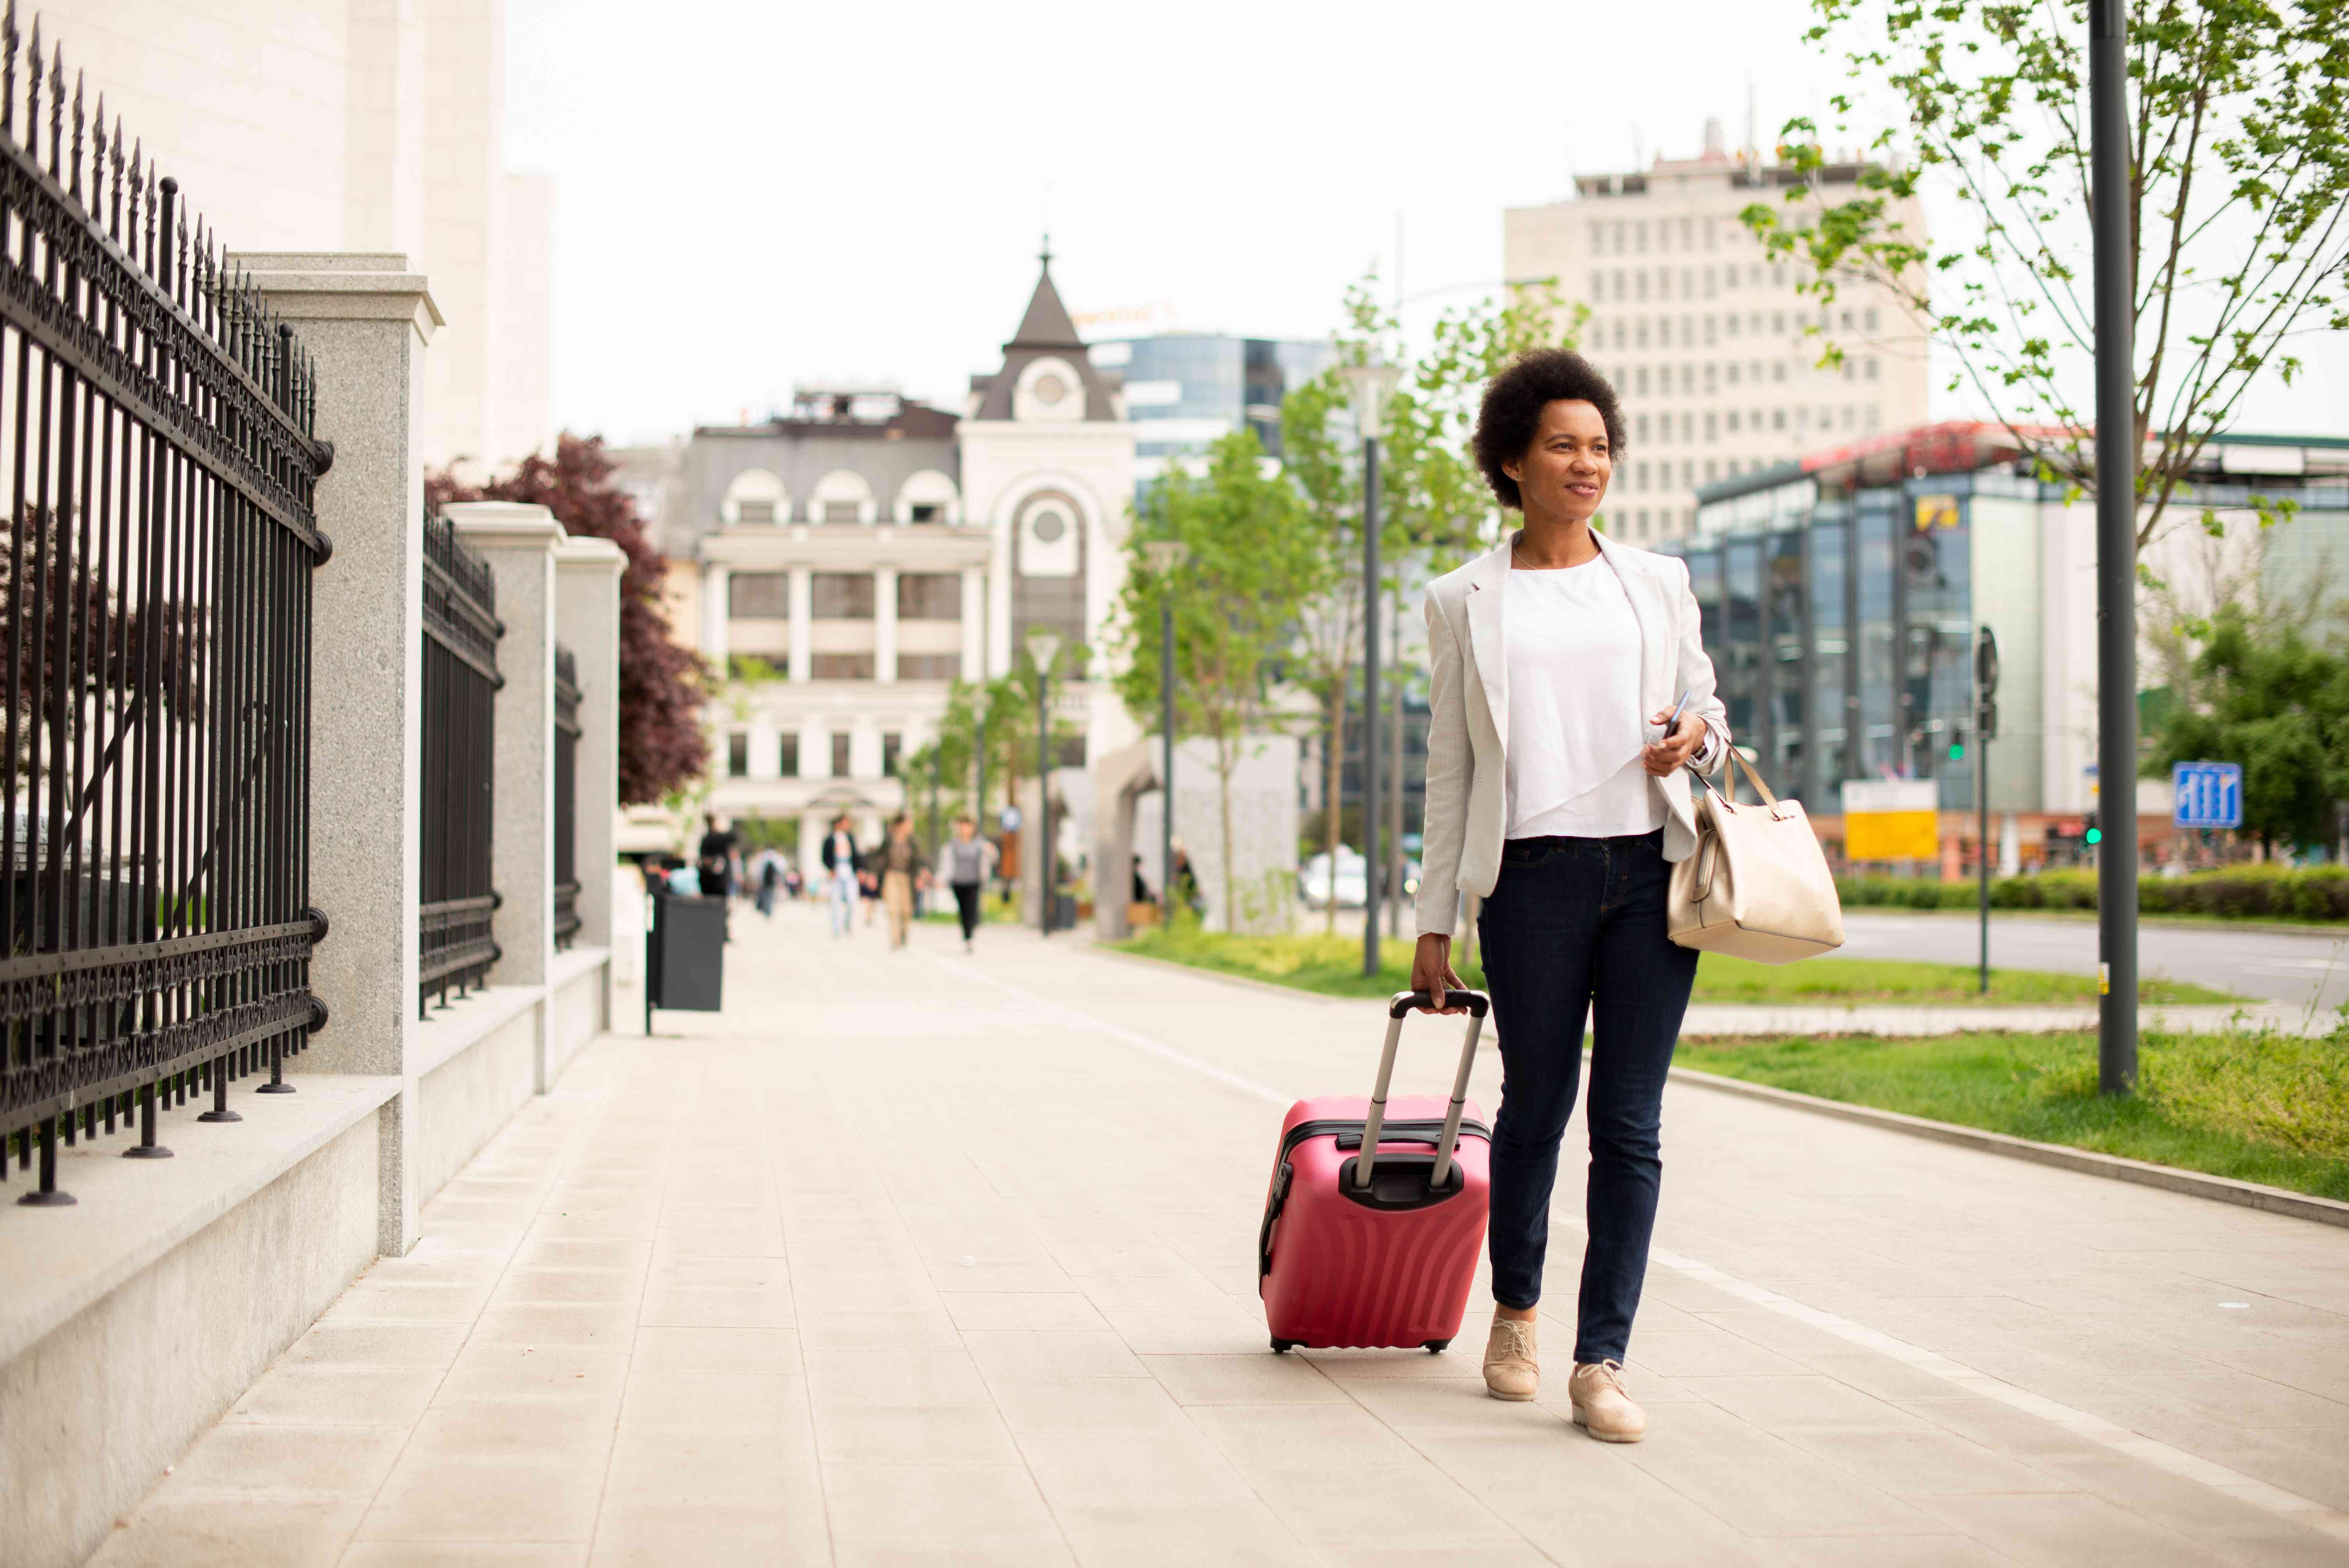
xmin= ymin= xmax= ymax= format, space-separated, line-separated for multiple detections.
xmin=0 ymin=7 xmax=331 ymax=1204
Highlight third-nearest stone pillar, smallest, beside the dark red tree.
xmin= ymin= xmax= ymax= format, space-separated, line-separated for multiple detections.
xmin=554 ymin=538 xmax=627 ymax=948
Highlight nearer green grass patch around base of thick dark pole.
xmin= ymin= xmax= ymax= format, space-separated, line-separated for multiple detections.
xmin=1675 ymin=1021 xmax=2349 ymax=1199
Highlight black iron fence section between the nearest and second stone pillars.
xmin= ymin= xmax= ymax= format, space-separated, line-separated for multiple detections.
xmin=416 ymin=517 xmax=505 ymax=1012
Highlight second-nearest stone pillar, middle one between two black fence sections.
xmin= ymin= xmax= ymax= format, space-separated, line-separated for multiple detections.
xmin=446 ymin=500 xmax=564 ymax=991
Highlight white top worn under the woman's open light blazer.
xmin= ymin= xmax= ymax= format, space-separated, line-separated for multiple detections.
xmin=1501 ymin=556 xmax=1665 ymax=838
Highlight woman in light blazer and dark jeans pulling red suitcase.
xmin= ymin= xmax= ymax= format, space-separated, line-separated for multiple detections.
xmin=1412 ymin=350 xmax=1729 ymax=1443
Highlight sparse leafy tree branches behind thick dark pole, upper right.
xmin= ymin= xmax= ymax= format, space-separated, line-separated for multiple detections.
xmin=1743 ymin=0 xmax=2349 ymax=552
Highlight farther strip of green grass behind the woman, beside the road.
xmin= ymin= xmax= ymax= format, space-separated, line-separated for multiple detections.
xmin=1116 ymin=925 xmax=2236 ymax=1007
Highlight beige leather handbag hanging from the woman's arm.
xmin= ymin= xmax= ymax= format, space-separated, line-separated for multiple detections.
xmin=1668 ymin=751 xmax=1844 ymax=965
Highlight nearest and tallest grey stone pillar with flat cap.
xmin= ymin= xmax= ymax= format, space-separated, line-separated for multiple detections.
xmin=248 ymin=253 xmax=442 ymax=1258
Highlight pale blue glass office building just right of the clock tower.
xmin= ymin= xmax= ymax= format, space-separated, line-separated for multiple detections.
xmin=1092 ymin=331 xmax=1330 ymax=486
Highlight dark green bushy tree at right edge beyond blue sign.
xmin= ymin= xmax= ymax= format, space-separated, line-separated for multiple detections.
xmin=2147 ymin=606 xmax=2349 ymax=850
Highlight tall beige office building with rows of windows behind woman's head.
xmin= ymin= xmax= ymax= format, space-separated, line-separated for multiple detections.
xmin=1503 ymin=120 xmax=1926 ymax=545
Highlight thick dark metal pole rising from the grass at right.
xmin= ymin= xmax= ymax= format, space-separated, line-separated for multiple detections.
xmin=2088 ymin=0 xmax=2138 ymax=1094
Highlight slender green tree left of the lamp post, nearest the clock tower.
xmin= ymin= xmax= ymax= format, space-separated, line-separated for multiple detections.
xmin=1109 ymin=429 xmax=1325 ymax=927
